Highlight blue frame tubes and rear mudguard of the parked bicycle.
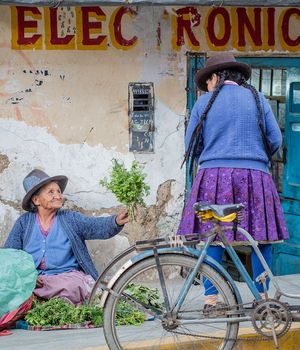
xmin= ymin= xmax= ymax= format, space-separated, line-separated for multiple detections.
xmin=96 ymin=223 xmax=300 ymax=323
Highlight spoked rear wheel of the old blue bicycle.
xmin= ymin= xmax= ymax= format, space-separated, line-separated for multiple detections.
xmin=103 ymin=254 xmax=239 ymax=350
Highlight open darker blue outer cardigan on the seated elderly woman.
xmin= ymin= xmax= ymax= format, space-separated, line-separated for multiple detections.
xmin=4 ymin=210 xmax=123 ymax=279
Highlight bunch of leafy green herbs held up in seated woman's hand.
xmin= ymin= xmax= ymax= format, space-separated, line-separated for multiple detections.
xmin=100 ymin=159 xmax=150 ymax=220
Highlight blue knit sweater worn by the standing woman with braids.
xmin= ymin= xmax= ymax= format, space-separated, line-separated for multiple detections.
xmin=185 ymin=85 xmax=282 ymax=172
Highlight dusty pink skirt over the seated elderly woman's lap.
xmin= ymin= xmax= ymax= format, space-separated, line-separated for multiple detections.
xmin=33 ymin=271 xmax=95 ymax=306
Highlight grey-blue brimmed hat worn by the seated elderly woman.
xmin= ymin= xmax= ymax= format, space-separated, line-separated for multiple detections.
xmin=22 ymin=169 xmax=68 ymax=211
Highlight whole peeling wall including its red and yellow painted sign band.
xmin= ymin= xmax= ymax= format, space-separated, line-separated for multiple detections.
xmin=0 ymin=6 xmax=300 ymax=269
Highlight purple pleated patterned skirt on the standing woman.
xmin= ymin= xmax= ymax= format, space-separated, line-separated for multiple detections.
xmin=177 ymin=168 xmax=288 ymax=243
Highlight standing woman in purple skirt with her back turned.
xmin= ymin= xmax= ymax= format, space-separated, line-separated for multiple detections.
xmin=178 ymin=52 xmax=288 ymax=307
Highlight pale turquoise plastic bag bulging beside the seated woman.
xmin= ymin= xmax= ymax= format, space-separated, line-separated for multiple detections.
xmin=0 ymin=248 xmax=37 ymax=318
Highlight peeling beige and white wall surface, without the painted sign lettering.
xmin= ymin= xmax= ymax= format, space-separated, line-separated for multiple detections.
xmin=0 ymin=7 xmax=186 ymax=269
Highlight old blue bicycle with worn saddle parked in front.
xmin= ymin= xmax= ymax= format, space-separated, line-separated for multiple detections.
xmin=91 ymin=203 xmax=300 ymax=350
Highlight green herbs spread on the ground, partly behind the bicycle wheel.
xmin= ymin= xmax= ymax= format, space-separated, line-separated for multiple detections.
xmin=25 ymin=284 xmax=162 ymax=327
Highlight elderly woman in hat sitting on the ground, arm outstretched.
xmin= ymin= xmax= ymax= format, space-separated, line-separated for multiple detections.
xmin=4 ymin=169 xmax=128 ymax=305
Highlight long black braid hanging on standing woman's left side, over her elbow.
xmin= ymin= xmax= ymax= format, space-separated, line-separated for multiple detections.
xmin=181 ymin=71 xmax=226 ymax=173
